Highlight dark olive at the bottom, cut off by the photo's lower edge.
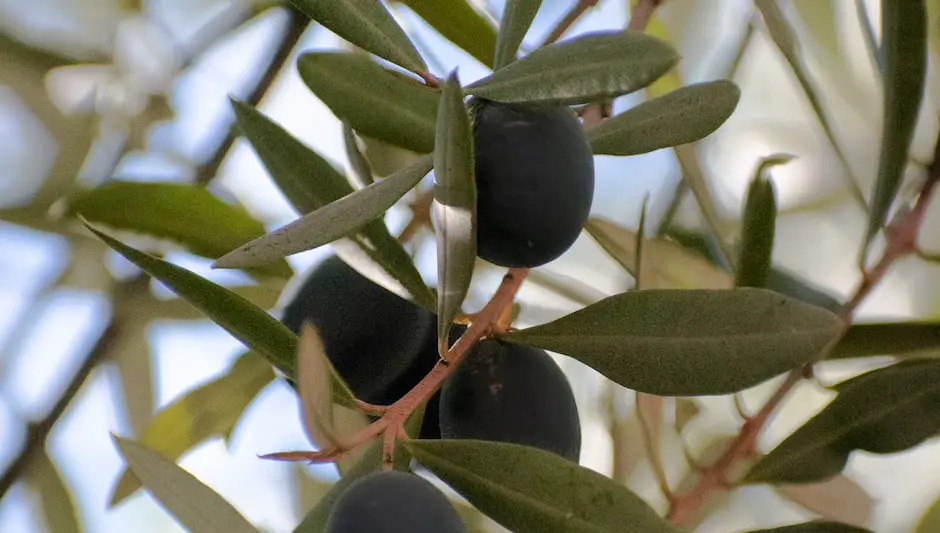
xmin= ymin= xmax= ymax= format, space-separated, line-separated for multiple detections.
xmin=325 ymin=470 xmax=467 ymax=533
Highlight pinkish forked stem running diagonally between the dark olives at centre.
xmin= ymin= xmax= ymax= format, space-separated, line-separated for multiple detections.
xmin=261 ymin=268 xmax=529 ymax=470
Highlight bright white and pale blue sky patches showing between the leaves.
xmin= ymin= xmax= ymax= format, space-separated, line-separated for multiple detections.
xmin=0 ymin=0 xmax=940 ymax=533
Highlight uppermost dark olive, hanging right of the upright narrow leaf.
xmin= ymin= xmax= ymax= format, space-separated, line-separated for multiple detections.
xmin=469 ymin=98 xmax=594 ymax=267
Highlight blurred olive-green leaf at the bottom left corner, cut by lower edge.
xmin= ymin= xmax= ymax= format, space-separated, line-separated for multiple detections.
xmin=25 ymin=450 xmax=82 ymax=533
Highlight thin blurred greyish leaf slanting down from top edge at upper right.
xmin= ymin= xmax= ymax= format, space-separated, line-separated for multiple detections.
xmin=754 ymin=0 xmax=867 ymax=210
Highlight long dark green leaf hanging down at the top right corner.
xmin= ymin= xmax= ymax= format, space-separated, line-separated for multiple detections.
xmin=868 ymin=0 xmax=927 ymax=241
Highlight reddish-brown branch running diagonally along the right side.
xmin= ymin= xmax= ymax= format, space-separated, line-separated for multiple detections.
xmin=666 ymin=148 xmax=940 ymax=525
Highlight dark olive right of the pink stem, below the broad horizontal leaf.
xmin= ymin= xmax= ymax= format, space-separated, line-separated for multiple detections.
xmin=440 ymin=340 xmax=581 ymax=462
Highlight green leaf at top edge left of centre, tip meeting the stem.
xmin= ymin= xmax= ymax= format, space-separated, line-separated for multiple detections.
xmin=291 ymin=0 xmax=427 ymax=72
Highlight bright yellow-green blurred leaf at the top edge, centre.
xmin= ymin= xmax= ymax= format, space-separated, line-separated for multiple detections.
xmin=399 ymin=0 xmax=496 ymax=68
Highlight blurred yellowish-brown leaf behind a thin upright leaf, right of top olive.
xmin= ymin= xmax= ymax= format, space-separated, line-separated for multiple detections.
xmin=584 ymin=217 xmax=734 ymax=289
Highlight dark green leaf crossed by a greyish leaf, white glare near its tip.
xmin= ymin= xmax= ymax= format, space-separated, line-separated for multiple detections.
xmin=233 ymin=97 xmax=436 ymax=310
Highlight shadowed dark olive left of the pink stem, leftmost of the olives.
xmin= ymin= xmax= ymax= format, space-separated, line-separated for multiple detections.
xmin=281 ymin=256 xmax=436 ymax=405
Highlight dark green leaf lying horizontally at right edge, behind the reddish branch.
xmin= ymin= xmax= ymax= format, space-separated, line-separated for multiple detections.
xmin=829 ymin=322 xmax=940 ymax=359
